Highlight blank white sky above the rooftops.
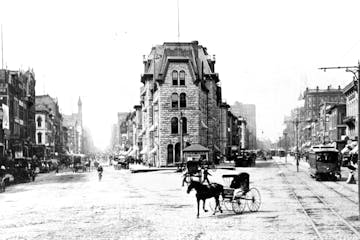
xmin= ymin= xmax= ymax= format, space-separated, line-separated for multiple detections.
xmin=0 ymin=0 xmax=360 ymax=148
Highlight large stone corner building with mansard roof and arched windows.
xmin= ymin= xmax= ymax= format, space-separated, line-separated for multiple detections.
xmin=135 ymin=41 xmax=226 ymax=166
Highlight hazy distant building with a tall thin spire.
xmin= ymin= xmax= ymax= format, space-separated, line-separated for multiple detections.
xmin=63 ymin=97 xmax=83 ymax=154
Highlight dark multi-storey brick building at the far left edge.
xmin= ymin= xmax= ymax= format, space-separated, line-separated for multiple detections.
xmin=0 ymin=69 xmax=36 ymax=157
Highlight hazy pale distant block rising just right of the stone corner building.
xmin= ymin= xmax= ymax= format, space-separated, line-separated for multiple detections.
xmin=230 ymin=102 xmax=257 ymax=149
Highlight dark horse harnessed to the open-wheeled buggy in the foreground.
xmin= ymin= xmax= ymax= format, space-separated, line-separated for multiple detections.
xmin=187 ymin=181 xmax=224 ymax=217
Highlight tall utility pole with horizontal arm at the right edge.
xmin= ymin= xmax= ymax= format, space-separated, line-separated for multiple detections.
xmin=319 ymin=61 xmax=360 ymax=218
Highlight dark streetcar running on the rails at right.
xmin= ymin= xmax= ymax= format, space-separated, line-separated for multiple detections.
xmin=308 ymin=145 xmax=341 ymax=180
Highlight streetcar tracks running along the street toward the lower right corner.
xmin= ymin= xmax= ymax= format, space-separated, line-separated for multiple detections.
xmin=275 ymin=162 xmax=360 ymax=239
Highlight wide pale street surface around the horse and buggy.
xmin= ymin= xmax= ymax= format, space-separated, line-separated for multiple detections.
xmin=0 ymin=158 xmax=360 ymax=240
